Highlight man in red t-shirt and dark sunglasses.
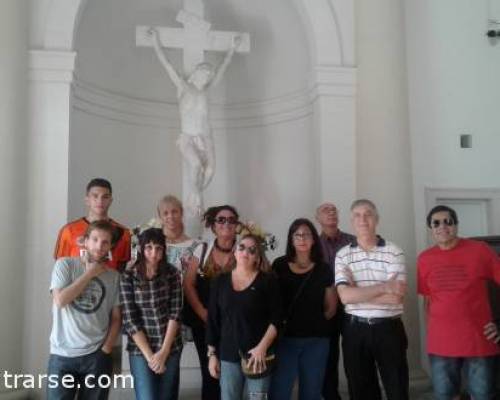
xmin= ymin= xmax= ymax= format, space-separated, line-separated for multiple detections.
xmin=417 ymin=205 xmax=500 ymax=400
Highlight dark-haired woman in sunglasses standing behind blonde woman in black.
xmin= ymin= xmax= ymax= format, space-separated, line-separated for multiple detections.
xmin=183 ymin=205 xmax=239 ymax=400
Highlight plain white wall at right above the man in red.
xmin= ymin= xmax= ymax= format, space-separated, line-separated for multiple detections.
xmin=405 ymin=0 xmax=500 ymax=250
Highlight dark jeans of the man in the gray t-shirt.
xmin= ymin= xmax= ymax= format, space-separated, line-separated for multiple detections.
xmin=47 ymin=349 xmax=113 ymax=400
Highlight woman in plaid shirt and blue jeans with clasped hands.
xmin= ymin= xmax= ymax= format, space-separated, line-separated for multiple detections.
xmin=120 ymin=228 xmax=182 ymax=400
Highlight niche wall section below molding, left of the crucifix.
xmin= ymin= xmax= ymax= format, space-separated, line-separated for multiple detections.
xmin=68 ymin=109 xmax=182 ymax=227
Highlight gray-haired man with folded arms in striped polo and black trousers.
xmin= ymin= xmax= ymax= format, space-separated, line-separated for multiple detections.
xmin=335 ymin=199 xmax=408 ymax=400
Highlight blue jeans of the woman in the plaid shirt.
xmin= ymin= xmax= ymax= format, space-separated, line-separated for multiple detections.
xmin=129 ymin=351 xmax=181 ymax=400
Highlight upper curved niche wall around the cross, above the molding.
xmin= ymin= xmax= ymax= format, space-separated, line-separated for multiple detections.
xmin=75 ymin=0 xmax=310 ymax=104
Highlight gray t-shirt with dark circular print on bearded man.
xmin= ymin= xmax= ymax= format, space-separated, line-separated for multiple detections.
xmin=50 ymin=258 xmax=120 ymax=357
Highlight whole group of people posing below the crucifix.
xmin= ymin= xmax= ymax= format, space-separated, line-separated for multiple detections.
xmin=47 ymin=178 xmax=500 ymax=400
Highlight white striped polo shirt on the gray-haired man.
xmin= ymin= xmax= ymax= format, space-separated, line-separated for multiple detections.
xmin=335 ymin=236 xmax=406 ymax=318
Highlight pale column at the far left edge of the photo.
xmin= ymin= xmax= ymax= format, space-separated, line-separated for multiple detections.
xmin=0 ymin=0 xmax=29 ymax=398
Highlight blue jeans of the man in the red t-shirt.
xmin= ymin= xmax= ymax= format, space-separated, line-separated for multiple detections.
xmin=429 ymin=354 xmax=495 ymax=400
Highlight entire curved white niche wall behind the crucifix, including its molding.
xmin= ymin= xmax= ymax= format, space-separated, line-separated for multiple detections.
xmin=68 ymin=0 xmax=318 ymax=236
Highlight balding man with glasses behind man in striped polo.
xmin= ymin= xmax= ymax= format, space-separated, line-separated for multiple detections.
xmin=316 ymin=202 xmax=354 ymax=400
